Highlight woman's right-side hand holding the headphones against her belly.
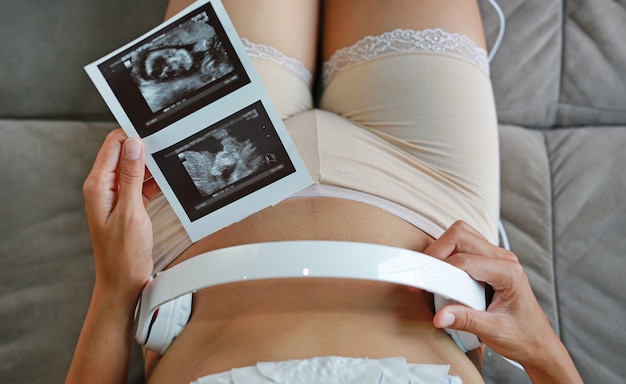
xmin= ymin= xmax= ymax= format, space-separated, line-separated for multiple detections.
xmin=424 ymin=222 xmax=582 ymax=383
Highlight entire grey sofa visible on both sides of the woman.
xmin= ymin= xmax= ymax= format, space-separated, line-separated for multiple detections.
xmin=0 ymin=0 xmax=626 ymax=383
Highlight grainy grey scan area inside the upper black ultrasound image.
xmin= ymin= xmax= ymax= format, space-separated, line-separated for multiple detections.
xmin=122 ymin=12 xmax=235 ymax=113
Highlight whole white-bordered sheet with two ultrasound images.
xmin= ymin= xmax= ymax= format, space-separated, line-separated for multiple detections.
xmin=85 ymin=0 xmax=312 ymax=241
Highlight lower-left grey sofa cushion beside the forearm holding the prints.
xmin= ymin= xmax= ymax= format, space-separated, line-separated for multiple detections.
xmin=0 ymin=120 xmax=142 ymax=383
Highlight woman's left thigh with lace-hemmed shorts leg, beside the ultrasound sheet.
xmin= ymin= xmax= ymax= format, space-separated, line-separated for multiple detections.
xmin=223 ymin=0 xmax=319 ymax=118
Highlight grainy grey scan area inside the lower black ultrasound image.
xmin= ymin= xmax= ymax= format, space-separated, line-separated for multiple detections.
xmin=178 ymin=128 xmax=266 ymax=197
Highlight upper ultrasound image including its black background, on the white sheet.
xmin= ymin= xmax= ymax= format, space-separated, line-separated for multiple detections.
xmin=97 ymin=3 xmax=250 ymax=137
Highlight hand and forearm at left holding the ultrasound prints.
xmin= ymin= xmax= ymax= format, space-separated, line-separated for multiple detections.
xmin=65 ymin=130 xmax=159 ymax=384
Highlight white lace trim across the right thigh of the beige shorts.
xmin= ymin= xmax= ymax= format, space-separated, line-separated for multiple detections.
xmin=323 ymin=29 xmax=489 ymax=84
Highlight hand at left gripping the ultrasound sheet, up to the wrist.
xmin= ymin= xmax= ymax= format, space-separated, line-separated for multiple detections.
xmin=83 ymin=129 xmax=159 ymax=304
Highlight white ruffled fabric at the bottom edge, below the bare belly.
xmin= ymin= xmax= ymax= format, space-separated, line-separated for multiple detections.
xmin=193 ymin=356 xmax=462 ymax=384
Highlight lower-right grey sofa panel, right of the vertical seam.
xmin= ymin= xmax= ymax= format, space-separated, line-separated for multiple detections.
xmin=547 ymin=127 xmax=626 ymax=383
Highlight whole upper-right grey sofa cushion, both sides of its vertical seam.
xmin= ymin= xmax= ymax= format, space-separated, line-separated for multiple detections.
xmin=480 ymin=0 xmax=626 ymax=128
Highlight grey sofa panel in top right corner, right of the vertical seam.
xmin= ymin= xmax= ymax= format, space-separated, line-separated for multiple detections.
xmin=556 ymin=0 xmax=626 ymax=126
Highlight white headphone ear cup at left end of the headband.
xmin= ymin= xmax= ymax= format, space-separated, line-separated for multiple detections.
xmin=144 ymin=293 xmax=192 ymax=355
